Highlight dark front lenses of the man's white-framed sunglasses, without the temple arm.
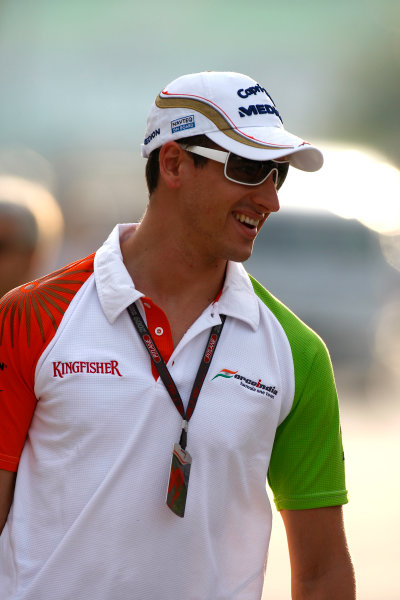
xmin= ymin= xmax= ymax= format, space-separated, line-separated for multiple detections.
xmin=226 ymin=152 xmax=289 ymax=189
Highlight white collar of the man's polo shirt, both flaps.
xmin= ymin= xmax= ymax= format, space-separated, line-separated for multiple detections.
xmin=94 ymin=223 xmax=260 ymax=330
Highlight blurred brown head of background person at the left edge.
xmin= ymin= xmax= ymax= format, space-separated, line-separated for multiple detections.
xmin=0 ymin=199 xmax=39 ymax=297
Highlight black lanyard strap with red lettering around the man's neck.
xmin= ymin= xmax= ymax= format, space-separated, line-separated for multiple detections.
xmin=128 ymin=302 xmax=226 ymax=450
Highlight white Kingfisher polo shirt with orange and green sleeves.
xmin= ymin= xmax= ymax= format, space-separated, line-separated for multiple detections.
xmin=0 ymin=225 xmax=347 ymax=600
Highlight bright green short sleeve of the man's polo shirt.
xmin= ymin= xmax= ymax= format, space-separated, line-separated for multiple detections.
xmin=251 ymin=278 xmax=348 ymax=510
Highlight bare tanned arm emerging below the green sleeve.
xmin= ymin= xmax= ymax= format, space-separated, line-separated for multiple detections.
xmin=281 ymin=506 xmax=355 ymax=600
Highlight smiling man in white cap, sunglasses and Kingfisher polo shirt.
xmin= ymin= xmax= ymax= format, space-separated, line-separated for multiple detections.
xmin=0 ymin=72 xmax=355 ymax=600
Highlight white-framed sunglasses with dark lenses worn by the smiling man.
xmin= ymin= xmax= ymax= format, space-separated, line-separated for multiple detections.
xmin=180 ymin=144 xmax=289 ymax=190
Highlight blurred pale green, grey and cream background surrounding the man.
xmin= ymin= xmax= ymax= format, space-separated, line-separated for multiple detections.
xmin=0 ymin=0 xmax=400 ymax=600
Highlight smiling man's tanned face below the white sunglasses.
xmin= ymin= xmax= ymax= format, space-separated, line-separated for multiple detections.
xmin=180 ymin=149 xmax=279 ymax=262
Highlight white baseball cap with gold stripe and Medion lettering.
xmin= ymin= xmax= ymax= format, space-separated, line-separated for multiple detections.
xmin=141 ymin=71 xmax=323 ymax=171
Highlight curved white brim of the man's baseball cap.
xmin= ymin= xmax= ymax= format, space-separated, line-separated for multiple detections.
xmin=205 ymin=127 xmax=324 ymax=171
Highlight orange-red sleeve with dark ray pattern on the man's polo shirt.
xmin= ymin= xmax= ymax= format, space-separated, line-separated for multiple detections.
xmin=0 ymin=255 xmax=94 ymax=471
